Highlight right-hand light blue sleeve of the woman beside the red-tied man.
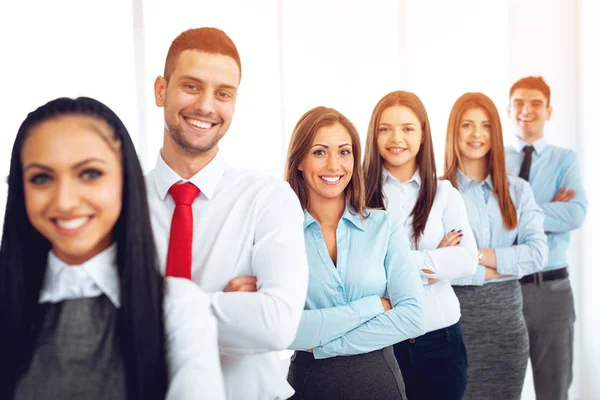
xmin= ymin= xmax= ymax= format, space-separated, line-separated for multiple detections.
xmin=313 ymin=220 xmax=425 ymax=359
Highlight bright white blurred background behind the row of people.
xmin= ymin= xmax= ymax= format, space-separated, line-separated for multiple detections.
xmin=0 ymin=0 xmax=600 ymax=400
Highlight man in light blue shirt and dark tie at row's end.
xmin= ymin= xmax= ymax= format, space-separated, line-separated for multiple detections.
xmin=506 ymin=76 xmax=587 ymax=400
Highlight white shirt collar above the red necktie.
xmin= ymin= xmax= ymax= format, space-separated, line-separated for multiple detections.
xmin=155 ymin=152 xmax=226 ymax=200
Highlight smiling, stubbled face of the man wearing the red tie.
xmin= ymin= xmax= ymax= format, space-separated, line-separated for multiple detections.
xmin=154 ymin=50 xmax=240 ymax=154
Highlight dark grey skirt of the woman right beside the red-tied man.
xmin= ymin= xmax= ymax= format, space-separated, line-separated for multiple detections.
xmin=288 ymin=346 xmax=406 ymax=400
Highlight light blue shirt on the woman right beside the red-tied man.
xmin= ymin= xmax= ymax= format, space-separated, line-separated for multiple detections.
xmin=290 ymin=209 xmax=425 ymax=359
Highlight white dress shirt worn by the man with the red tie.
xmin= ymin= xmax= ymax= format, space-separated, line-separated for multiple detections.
xmin=146 ymin=153 xmax=308 ymax=400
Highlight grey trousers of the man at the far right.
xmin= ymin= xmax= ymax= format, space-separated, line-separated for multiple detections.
xmin=521 ymin=278 xmax=575 ymax=400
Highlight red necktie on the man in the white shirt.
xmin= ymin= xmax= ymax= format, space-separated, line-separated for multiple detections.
xmin=167 ymin=182 xmax=200 ymax=279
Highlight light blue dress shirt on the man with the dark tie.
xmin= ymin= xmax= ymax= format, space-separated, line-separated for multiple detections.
xmin=506 ymin=137 xmax=587 ymax=271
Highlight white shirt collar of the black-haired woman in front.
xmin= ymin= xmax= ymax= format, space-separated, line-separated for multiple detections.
xmin=41 ymin=243 xmax=121 ymax=308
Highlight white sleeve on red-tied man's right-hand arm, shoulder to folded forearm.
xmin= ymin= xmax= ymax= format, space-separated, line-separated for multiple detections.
xmin=211 ymin=181 xmax=308 ymax=354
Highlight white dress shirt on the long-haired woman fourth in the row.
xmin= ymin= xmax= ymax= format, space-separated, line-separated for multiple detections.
xmin=382 ymin=169 xmax=478 ymax=332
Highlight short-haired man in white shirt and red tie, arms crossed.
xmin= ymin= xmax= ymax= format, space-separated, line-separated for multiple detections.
xmin=146 ymin=28 xmax=308 ymax=400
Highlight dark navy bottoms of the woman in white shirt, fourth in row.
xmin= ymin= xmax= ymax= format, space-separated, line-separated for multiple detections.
xmin=394 ymin=322 xmax=467 ymax=400
